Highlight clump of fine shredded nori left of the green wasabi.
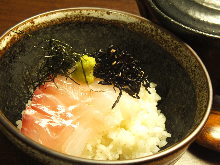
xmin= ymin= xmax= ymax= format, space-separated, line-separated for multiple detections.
xmin=36 ymin=39 xmax=82 ymax=82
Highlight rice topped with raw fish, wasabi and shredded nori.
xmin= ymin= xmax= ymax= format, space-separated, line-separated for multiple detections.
xmin=14 ymin=39 xmax=171 ymax=160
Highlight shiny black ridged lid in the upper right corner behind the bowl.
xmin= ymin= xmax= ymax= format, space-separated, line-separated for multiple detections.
xmin=146 ymin=0 xmax=220 ymax=38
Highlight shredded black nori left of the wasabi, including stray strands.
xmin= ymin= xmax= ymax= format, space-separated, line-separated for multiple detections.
xmin=10 ymin=31 xmax=83 ymax=86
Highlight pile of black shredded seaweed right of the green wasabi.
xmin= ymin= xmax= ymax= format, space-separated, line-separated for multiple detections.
xmin=93 ymin=45 xmax=149 ymax=108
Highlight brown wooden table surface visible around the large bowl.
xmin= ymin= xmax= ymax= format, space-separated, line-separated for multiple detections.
xmin=0 ymin=0 xmax=220 ymax=165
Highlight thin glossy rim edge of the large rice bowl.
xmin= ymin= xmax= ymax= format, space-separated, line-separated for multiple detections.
xmin=0 ymin=7 xmax=213 ymax=165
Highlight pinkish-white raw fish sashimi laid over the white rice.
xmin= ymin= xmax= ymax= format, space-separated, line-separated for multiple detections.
xmin=21 ymin=76 xmax=118 ymax=156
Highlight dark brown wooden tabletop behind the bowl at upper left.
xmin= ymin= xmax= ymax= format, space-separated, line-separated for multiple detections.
xmin=0 ymin=0 xmax=139 ymax=34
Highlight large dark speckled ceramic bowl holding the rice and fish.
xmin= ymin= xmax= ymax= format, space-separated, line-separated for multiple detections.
xmin=0 ymin=8 xmax=212 ymax=165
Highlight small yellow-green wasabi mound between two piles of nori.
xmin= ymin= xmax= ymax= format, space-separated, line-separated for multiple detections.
xmin=71 ymin=55 xmax=96 ymax=84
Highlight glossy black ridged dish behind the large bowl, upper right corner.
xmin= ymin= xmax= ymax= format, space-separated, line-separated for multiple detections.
xmin=137 ymin=0 xmax=220 ymax=38
